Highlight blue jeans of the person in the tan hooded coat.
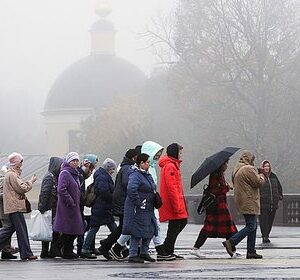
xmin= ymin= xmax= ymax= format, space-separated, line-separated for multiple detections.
xmin=230 ymin=214 xmax=257 ymax=253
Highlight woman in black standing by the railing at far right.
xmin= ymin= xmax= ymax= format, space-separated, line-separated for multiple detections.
xmin=259 ymin=160 xmax=283 ymax=243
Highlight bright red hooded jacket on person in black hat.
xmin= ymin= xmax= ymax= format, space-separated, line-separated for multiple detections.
xmin=158 ymin=156 xmax=188 ymax=222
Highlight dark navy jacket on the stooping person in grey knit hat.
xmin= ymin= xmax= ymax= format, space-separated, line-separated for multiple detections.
xmin=90 ymin=167 xmax=114 ymax=227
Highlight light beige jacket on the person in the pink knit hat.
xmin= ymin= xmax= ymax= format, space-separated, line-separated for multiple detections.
xmin=3 ymin=168 xmax=32 ymax=214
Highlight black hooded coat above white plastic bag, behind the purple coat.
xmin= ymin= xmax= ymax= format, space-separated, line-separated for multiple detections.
xmin=38 ymin=157 xmax=63 ymax=213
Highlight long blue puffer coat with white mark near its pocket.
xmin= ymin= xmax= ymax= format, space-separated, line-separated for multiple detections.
xmin=122 ymin=169 xmax=157 ymax=238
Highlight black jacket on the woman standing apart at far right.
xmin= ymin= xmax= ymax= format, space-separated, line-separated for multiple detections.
xmin=260 ymin=172 xmax=282 ymax=211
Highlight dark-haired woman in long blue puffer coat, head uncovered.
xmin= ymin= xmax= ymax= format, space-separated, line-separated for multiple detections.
xmin=122 ymin=153 xmax=157 ymax=263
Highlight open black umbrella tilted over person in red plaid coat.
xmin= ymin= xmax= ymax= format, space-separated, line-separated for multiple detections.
xmin=191 ymin=147 xmax=240 ymax=188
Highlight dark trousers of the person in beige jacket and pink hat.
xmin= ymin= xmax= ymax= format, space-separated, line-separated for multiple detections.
xmin=0 ymin=212 xmax=33 ymax=259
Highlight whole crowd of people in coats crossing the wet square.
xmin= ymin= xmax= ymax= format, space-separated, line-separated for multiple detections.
xmin=0 ymin=141 xmax=283 ymax=263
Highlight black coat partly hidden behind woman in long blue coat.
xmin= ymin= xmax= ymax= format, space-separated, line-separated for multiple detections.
xmin=113 ymin=157 xmax=134 ymax=216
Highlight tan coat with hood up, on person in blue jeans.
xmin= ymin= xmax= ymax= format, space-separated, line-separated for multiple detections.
xmin=232 ymin=151 xmax=265 ymax=215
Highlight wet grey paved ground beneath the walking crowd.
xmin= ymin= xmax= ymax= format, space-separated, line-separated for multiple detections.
xmin=0 ymin=224 xmax=300 ymax=280
